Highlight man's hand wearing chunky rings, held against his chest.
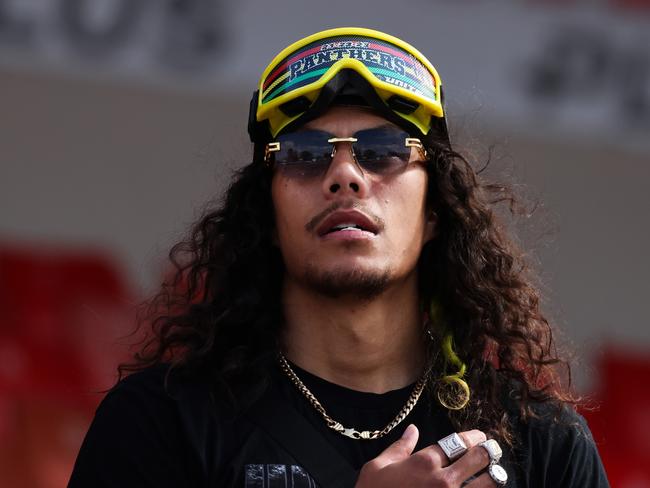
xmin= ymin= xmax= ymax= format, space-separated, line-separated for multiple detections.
xmin=355 ymin=424 xmax=496 ymax=488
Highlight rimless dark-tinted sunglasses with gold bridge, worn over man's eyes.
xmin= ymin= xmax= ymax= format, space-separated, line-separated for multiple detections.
xmin=264 ymin=127 xmax=427 ymax=178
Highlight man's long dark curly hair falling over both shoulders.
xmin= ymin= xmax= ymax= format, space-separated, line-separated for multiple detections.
xmin=119 ymin=132 xmax=577 ymax=444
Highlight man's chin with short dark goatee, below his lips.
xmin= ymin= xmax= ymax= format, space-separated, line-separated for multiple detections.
xmin=301 ymin=268 xmax=390 ymax=300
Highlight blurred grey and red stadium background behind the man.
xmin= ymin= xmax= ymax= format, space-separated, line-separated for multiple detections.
xmin=0 ymin=0 xmax=650 ymax=488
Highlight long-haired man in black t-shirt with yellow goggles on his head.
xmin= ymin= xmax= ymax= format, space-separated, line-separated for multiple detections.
xmin=70 ymin=28 xmax=608 ymax=488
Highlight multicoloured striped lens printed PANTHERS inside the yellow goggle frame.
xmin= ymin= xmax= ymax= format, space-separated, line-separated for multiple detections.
xmin=261 ymin=35 xmax=437 ymax=105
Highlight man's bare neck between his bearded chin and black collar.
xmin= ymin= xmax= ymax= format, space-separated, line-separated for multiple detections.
xmin=283 ymin=276 xmax=425 ymax=393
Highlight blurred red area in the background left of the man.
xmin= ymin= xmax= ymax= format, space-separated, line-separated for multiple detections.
xmin=0 ymin=245 xmax=134 ymax=488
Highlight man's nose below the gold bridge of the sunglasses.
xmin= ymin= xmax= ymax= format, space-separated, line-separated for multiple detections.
xmin=323 ymin=142 xmax=368 ymax=198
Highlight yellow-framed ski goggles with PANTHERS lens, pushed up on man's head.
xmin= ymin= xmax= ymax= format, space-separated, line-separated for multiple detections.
xmin=249 ymin=27 xmax=446 ymax=141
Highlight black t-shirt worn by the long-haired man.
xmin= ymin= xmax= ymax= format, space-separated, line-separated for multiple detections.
xmin=68 ymin=367 xmax=609 ymax=488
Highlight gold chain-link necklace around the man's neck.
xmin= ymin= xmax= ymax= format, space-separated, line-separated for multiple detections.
xmin=279 ymin=353 xmax=427 ymax=440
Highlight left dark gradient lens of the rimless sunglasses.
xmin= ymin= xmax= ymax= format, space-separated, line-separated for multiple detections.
xmin=274 ymin=130 xmax=332 ymax=178
